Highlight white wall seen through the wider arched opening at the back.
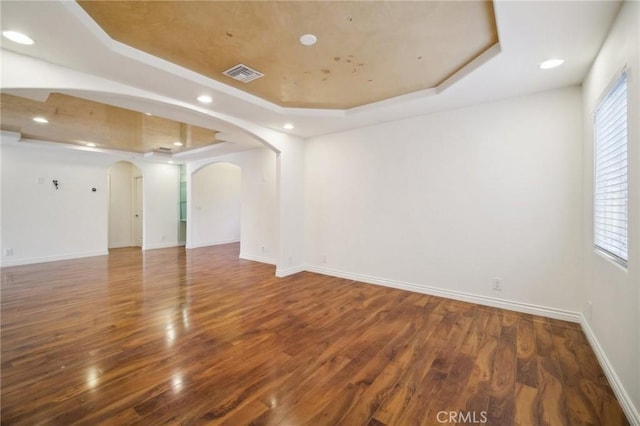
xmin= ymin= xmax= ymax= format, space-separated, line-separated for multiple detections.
xmin=191 ymin=163 xmax=242 ymax=247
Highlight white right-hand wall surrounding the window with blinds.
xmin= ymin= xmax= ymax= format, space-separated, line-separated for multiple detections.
xmin=581 ymin=1 xmax=640 ymax=424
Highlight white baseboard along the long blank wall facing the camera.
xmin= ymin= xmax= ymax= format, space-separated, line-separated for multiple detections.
xmin=306 ymin=265 xmax=580 ymax=323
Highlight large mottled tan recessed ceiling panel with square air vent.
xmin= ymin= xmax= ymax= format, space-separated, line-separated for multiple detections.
xmin=79 ymin=0 xmax=498 ymax=109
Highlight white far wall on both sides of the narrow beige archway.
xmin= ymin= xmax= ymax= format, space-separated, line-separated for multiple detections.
xmin=0 ymin=137 xmax=179 ymax=266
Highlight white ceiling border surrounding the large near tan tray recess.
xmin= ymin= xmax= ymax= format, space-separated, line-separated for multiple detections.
xmin=0 ymin=0 xmax=621 ymax=152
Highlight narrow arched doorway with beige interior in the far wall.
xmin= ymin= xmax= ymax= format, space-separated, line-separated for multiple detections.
xmin=108 ymin=161 xmax=144 ymax=249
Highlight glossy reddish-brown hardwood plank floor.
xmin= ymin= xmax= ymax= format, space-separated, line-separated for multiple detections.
xmin=1 ymin=244 xmax=627 ymax=426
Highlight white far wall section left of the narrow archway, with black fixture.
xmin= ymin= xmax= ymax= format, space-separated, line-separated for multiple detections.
xmin=0 ymin=141 xmax=108 ymax=266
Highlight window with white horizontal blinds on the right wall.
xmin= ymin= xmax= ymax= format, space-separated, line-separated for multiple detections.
xmin=593 ymin=73 xmax=628 ymax=266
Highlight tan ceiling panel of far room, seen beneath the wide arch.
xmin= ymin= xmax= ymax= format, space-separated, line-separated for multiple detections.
xmin=0 ymin=93 xmax=221 ymax=154
